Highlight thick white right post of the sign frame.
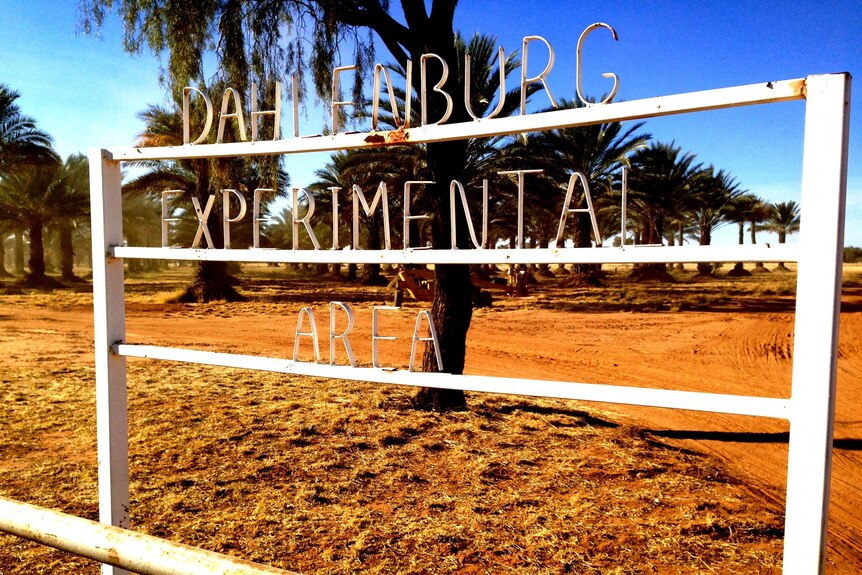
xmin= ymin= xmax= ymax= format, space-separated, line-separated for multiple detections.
xmin=784 ymin=74 xmax=850 ymax=575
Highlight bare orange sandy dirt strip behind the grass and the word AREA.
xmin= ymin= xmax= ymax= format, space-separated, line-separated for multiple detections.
xmin=0 ymin=289 xmax=862 ymax=575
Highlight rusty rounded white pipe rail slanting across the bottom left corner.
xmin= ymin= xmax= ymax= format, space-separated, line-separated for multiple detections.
xmin=0 ymin=497 xmax=296 ymax=575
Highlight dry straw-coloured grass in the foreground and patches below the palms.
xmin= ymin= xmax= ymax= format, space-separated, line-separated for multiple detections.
xmin=0 ymin=268 xmax=796 ymax=575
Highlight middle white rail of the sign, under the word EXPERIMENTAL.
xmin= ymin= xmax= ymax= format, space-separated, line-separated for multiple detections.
xmin=109 ymin=244 xmax=798 ymax=264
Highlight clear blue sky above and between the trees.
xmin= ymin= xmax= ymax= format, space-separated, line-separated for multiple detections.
xmin=0 ymin=0 xmax=862 ymax=246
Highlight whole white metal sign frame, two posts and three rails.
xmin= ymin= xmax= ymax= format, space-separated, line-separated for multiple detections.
xmin=77 ymin=74 xmax=850 ymax=575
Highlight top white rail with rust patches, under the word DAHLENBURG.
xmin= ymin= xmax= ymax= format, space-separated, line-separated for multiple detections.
xmin=105 ymin=79 xmax=806 ymax=161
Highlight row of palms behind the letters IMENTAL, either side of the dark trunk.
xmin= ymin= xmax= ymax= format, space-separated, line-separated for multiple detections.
xmin=296 ymin=98 xmax=800 ymax=284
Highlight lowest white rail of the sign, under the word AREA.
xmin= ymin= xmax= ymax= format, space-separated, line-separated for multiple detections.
xmin=118 ymin=343 xmax=789 ymax=419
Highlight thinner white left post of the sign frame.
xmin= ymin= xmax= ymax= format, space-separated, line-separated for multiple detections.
xmin=89 ymin=149 xmax=129 ymax=575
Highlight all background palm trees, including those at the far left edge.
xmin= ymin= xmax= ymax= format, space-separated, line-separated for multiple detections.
xmin=0 ymin=25 xmax=799 ymax=290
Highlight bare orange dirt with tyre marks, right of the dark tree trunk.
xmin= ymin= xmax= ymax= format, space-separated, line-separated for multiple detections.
xmin=468 ymin=311 xmax=862 ymax=575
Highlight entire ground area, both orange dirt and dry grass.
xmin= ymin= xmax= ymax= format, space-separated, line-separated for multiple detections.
xmin=0 ymin=268 xmax=862 ymax=575
